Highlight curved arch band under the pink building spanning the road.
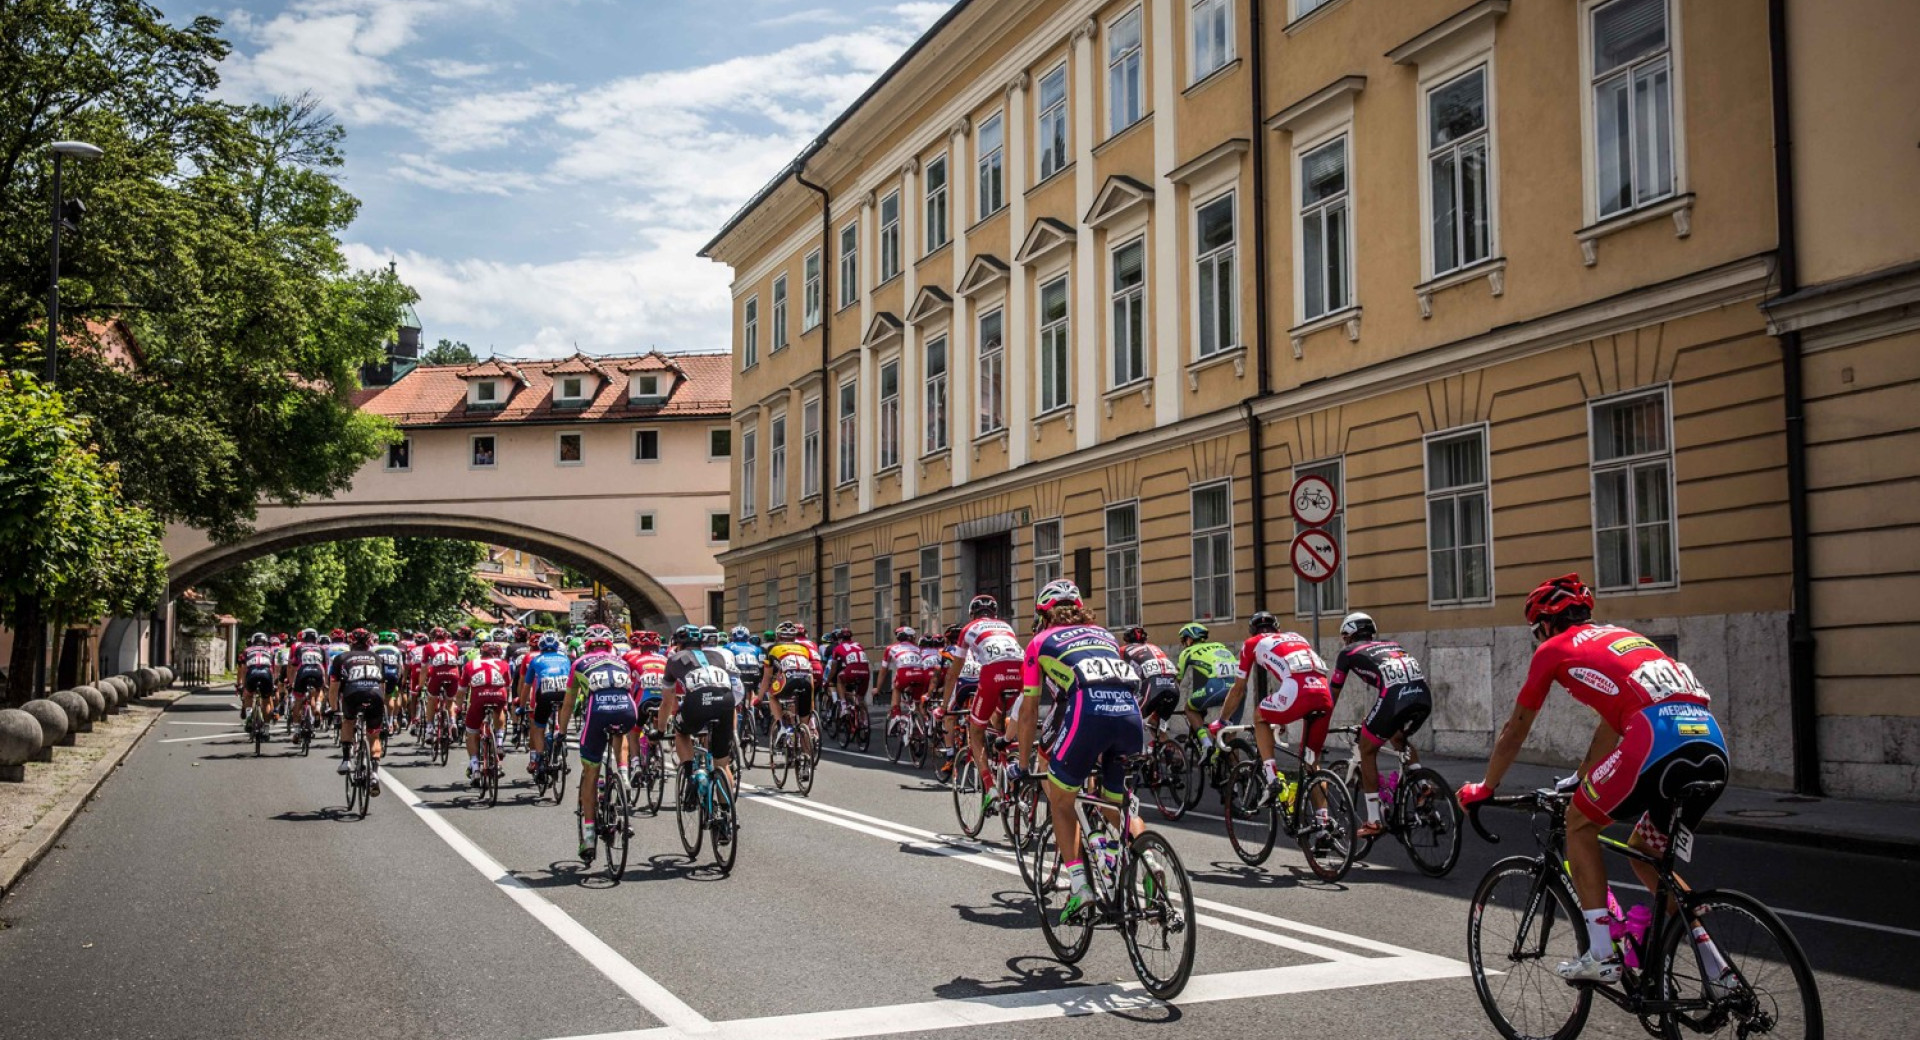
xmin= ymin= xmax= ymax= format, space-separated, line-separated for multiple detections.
xmin=167 ymin=512 xmax=687 ymax=631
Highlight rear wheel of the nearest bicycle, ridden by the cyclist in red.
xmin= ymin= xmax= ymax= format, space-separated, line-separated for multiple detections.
xmin=1651 ymin=890 xmax=1826 ymax=1040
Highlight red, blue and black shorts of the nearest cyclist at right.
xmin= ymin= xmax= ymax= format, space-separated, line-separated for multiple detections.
xmin=1572 ymin=698 xmax=1732 ymax=837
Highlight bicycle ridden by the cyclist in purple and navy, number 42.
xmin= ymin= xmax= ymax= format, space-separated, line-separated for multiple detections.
xmin=1029 ymin=769 xmax=1198 ymax=1000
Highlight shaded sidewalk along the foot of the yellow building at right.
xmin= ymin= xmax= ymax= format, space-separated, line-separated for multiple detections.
xmin=1421 ymin=754 xmax=1920 ymax=858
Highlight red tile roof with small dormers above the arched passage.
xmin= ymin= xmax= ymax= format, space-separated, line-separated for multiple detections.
xmin=353 ymin=351 xmax=733 ymax=426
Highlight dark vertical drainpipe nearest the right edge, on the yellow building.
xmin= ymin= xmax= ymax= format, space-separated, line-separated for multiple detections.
xmin=1766 ymin=0 xmax=1820 ymax=794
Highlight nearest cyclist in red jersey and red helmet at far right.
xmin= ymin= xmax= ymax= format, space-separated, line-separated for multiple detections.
xmin=1459 ymin=574 xmax=1732 ymax=982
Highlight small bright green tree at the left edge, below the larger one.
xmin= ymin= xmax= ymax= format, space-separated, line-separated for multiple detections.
xmin=0 ymin=372 xmax=167 ymax=704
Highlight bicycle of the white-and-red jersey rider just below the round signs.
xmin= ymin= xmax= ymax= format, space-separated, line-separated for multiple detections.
xmin=1221 ymin=712 xmax=1356 ymax=881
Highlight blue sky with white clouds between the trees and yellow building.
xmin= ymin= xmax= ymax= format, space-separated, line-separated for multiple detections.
xmin=176 ymin=0 xmax=948 ymax=357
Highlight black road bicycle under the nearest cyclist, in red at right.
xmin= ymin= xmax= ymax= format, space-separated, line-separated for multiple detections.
xmin=1467 ymin=781 xmax=1824 ymax=1040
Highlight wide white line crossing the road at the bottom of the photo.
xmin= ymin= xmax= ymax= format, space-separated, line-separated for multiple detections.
xmin=549 ymin=954 xmax=1467 ymax=1040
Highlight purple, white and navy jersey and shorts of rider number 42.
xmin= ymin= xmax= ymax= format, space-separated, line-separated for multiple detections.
xmin=1020 ymin=626 xmax=1144 ymax=798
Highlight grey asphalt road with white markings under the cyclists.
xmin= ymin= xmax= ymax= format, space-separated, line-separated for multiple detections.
xmin=0 ymin=693 xmax=1920 ymax=1040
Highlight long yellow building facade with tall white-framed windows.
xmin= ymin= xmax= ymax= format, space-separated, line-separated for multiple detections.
xmin=705 ymin=0 xmax=1920 ymax=796
